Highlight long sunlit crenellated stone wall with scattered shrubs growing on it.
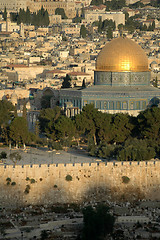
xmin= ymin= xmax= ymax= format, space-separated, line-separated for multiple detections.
xmin=0 ymin=161 xmax=160 ymax=207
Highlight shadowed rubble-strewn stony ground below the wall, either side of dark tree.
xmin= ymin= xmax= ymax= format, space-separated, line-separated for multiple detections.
xmin=0 ymin=201 xmax=160 ymax=240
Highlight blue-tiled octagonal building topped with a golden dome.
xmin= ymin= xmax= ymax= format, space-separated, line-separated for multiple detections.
xmin=56 ymin=37 xmax=160 ymax=116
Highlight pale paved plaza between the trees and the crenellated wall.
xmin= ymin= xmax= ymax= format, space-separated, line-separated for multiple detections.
xmin=0 ymin=148 xmax=101 ymax=165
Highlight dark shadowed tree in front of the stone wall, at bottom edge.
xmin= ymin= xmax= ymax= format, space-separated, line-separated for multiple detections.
xmin=82 ymin=205 xmax=115 ymax=240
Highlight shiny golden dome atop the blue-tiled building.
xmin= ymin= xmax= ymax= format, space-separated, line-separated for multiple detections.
xmin=96 ymin=37 xmax=149 ymax=72
